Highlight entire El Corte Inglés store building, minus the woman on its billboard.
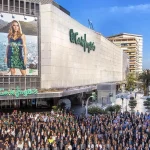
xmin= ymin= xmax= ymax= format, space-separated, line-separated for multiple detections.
xmin=0 ymin=0 xmax=126 ymax=108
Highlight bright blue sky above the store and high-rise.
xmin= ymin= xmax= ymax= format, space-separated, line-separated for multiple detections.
xmin=55 ymin=0 xmax=150 ymax=69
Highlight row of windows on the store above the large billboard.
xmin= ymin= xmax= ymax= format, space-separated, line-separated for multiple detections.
xmin=0 ymin=0 xmax=39 ymax=16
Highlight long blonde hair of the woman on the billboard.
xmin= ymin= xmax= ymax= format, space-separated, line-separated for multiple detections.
xmin=8 ymin=20 xmax=22 ymax=38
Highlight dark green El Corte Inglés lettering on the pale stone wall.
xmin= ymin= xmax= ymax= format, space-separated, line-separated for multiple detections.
xmin=69 ymin=29 xmax=96 ymax=53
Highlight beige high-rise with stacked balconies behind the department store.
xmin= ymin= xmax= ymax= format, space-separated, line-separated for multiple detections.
xmin=108 ymin=33 xmax=143 ymax=73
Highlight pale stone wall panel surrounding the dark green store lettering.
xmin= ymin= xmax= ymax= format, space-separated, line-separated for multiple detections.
xmin=41 ymin=4 xmax=122 ymax=88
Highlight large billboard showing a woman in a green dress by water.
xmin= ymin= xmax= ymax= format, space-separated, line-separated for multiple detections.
xmin=0 ymin=13 xmax=38 ymax=76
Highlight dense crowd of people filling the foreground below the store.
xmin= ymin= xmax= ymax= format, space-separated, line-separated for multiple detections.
xmin=0 ymin=111 xmax=150 ymax=150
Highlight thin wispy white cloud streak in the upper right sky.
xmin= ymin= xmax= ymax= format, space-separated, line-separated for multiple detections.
xmin=110 ymin=4 xmax=150 ymax=13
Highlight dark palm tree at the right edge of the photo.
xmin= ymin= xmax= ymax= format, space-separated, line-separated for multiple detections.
xmin=139 ymin=69 xmax=150 ymax=95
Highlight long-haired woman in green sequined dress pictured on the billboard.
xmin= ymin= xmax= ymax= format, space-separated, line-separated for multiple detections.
xmin=5 ymin=20 xmax=27 ymax=75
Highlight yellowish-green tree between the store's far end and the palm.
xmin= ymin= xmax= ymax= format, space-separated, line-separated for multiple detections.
xmin=126 ymin=72 xmax=137 ymax=91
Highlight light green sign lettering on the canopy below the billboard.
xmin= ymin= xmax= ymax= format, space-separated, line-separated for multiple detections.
xmin=0 ymin=87 xmax=38 ymax=98
